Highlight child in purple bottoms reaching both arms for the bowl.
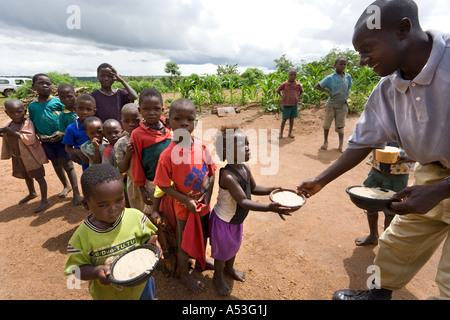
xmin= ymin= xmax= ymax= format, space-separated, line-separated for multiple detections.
xmin=210 ymin=127 xmax=290 ymax=296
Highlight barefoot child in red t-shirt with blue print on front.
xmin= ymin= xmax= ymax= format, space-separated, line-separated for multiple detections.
xmin=153 ymin=99 xmax=216 ymax=293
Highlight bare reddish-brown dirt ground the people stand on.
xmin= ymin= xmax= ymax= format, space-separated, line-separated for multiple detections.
xmin=0 ymin=101 xmax=441 ymax=300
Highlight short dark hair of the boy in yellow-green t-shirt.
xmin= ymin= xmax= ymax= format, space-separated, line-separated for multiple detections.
xmin=81 ymin=163 xmax=122 ymax=200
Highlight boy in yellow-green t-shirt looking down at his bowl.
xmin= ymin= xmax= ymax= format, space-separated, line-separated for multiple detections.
xmin=64 ymin=164 xmax=162 ymax=300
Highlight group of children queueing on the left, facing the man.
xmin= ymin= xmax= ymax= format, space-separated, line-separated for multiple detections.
xmin=0 ymin=64 xmax=298 ymax=299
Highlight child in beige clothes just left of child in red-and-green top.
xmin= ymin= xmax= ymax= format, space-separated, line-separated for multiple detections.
xmin=114 ymin=103 xmax=144 ymax=211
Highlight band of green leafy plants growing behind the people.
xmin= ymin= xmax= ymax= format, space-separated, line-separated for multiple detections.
xmin=13 ymin=48 xmax=380 ymax=113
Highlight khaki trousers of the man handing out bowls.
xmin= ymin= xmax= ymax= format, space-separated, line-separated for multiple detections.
xmin=374 ymin=164 xmax=450 ymax=299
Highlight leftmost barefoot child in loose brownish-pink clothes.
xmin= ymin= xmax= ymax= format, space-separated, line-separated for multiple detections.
xmin=0 ymin=99 xmax=49 ymax=213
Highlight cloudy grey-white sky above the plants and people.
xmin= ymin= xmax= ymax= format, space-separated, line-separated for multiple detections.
xmin=0 ymin=0 xmax=450 ymax=76
